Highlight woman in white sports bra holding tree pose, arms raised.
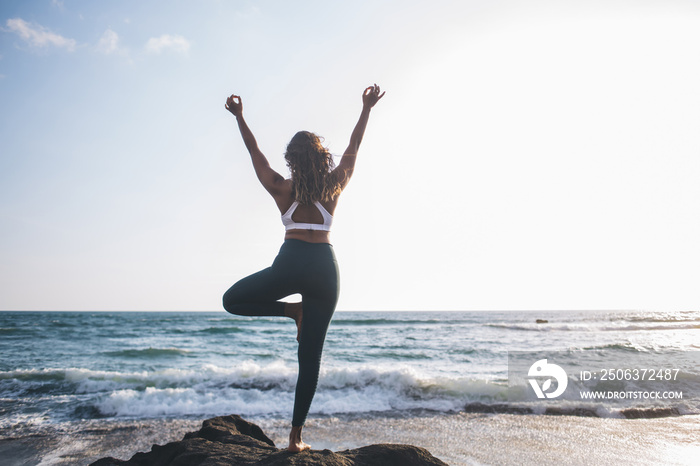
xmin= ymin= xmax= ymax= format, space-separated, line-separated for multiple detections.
xmin=224 ymin=84 xmax=384 ymax=452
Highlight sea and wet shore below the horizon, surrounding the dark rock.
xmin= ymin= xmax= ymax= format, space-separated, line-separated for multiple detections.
xmin=0 ymin=311 xmax=700 ymax=465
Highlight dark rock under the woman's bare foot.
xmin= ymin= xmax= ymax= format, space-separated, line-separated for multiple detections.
xmin=91 ymin=415 xmax=446 ymax=466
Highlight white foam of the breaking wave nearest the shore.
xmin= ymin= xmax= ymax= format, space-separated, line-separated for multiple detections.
xmin=2 ymin=361 xmax=696 ymax=418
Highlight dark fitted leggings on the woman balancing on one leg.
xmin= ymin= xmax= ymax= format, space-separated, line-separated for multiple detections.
xmin=224 ymin=239 xmax=340 ymax=426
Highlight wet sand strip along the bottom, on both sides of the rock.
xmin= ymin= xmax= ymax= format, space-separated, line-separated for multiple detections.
xmin=0 ymin=413 xmax=700 ymax=466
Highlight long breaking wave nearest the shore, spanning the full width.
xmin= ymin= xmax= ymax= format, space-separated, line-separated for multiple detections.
xmin=0 ymin=361 xmax=700 ymax=422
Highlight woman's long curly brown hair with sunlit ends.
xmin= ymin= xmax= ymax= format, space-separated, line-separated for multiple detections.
xmin=284 ymin=131 xmax=342 ymax=204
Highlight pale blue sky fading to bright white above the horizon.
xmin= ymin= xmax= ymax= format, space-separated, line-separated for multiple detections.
xmin=0 ymin=0 xmax=700 ymax=311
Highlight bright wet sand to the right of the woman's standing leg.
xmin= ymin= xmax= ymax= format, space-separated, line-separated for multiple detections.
xmin=266 ymin=413 xmax=700 ymax=466
